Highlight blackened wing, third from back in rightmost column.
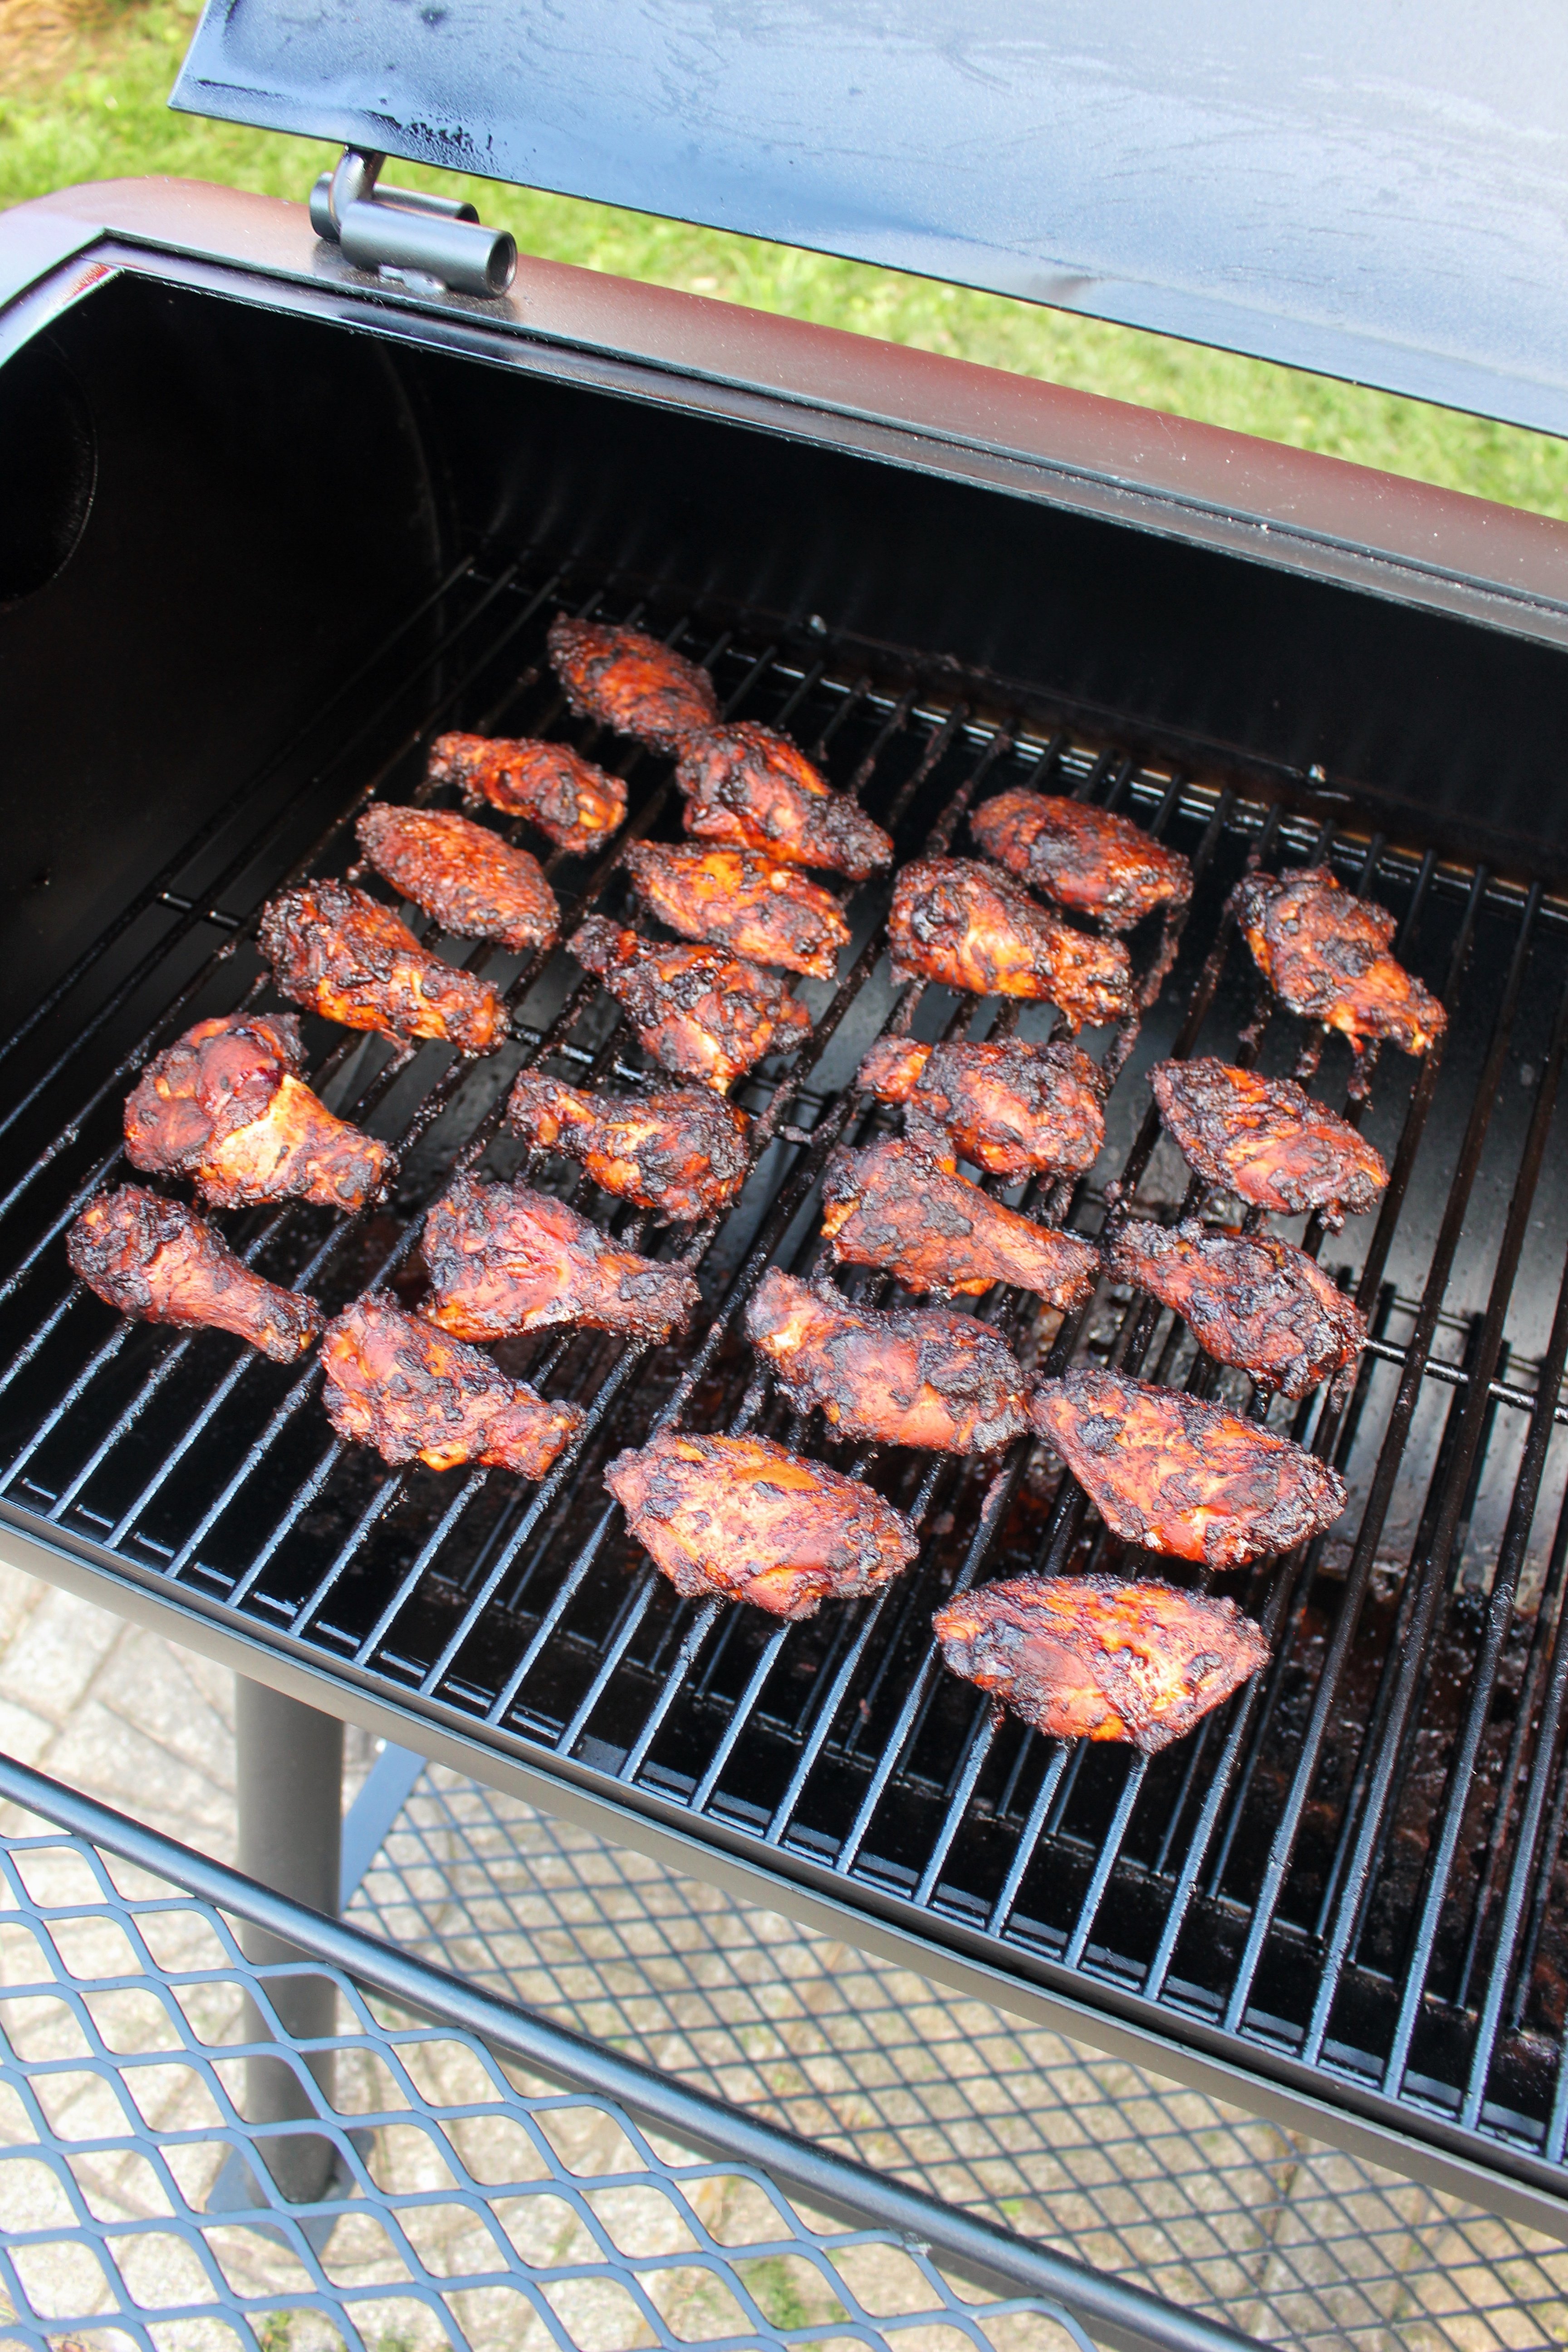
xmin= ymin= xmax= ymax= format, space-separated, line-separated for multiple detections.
xmin=1105 ymin=1218 xmax=1366 ymax=1397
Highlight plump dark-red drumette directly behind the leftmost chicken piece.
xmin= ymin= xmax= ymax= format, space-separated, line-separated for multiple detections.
xmin=125 ymin=1014 xmax=397 ymax=1209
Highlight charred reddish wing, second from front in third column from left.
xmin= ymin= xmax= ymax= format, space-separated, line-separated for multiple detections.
xmin=745 ymin=1268 xmax=1029 ymax=1454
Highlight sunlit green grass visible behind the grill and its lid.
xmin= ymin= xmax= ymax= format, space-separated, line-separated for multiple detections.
xmin=0 ymin=0 xmax=1568 ymax=517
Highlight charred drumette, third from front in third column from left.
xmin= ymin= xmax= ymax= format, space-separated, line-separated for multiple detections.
xmin=823 ymin=1136 xmax=1100 ymax=1308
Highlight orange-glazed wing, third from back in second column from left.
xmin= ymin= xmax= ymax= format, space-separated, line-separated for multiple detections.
xmin=625 ymin=842 xmax=848 ymax=981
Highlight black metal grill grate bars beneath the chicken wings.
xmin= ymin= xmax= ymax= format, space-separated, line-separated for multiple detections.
xmin=0 ymin=558 xmax=1568 ymax=2166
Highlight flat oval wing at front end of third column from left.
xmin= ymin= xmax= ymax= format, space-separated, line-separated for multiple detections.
xmin=604 ymin=1430 xmax=919 ymax=1618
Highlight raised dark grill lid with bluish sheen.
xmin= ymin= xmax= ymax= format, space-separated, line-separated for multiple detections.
xmin=174 ymin=0 xmax=1568 ymax=433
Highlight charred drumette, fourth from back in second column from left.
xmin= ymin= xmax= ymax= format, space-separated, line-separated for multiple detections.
xmin=567 ymin=915 xmax=811 ymax=1094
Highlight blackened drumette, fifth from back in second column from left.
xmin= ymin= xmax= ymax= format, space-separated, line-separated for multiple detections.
xmin=505 ymin=1070 xmax=750 ymax=1223
